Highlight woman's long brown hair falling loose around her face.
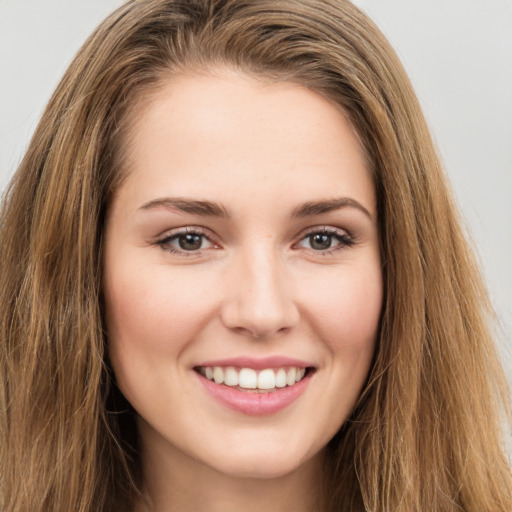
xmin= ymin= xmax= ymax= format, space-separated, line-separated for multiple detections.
xmin=0 ymin=0 xmax=512 ymax=512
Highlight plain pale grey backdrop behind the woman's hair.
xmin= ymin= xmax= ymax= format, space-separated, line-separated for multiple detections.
xmin=0 ymin=0 xmax=512 ymax=375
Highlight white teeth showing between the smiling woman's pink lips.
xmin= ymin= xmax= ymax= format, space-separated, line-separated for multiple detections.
xmin=194 ymin=366 xmax=314 ymax=393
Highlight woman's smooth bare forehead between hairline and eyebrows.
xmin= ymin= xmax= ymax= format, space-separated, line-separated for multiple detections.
xmin=114 ymin=71 xmax=374 ymax=215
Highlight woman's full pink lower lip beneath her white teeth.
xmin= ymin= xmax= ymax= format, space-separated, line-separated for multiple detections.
xmin=196 ymin=373 xmax=312 ymax=416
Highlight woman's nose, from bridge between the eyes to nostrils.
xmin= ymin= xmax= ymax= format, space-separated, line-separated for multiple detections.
xmin=221 ymin=245 xmax=300 ymax=339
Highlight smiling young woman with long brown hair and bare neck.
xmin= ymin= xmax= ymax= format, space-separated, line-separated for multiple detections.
xmin=0 ymin=0 xmax=512 ymax=512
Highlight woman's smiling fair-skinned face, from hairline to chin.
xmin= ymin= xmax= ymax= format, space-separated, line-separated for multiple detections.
xmin=104 ymin=72 xmax=382 ymax=478
